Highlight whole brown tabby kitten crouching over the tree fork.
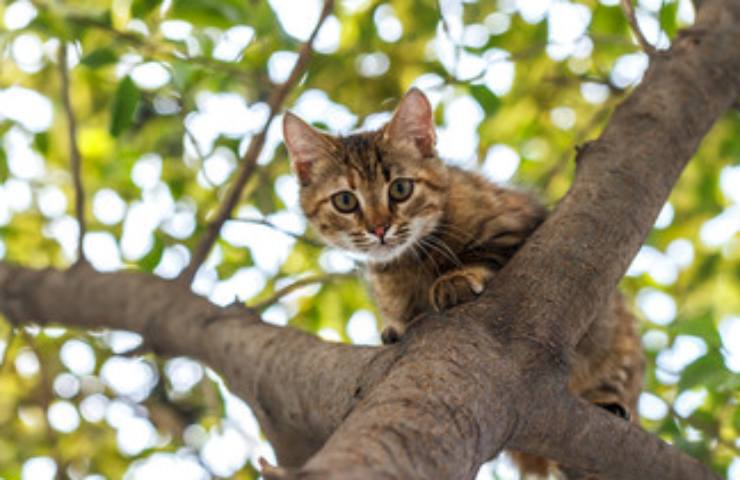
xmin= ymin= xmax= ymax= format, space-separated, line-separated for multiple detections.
xmin=283 ymin=88 xmax=644 ymax=475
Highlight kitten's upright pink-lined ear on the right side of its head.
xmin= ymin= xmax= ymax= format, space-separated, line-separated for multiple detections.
xmin=383 ymin=87 xmax=437 ymax=157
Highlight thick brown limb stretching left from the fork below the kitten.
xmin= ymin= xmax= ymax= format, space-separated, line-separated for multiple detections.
xmin=0 ymin=262 xmax=376 ymax=465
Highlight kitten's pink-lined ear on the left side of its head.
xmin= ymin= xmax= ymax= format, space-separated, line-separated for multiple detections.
xmin=283 ymin=112 xmax=333 ymax=186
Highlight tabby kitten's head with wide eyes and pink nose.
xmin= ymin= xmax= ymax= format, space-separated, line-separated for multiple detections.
xmin=283 ymin=89 xmax=448 ymax=263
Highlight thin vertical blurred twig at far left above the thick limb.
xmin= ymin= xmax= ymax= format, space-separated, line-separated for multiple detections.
xmin=57 ymin=42 xmax=87 ymax=262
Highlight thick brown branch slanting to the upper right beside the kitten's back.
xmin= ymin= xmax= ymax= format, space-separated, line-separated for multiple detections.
xmin=490 ymin=0 xmax=740 ymax=350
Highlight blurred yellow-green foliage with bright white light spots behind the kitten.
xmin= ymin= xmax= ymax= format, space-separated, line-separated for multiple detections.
xmin=0 ymin=0 xmax=740 ymax=479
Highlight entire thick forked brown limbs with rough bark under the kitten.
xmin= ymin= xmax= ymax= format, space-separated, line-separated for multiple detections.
xmin=0 ymin=0 xmax=740 ymax=480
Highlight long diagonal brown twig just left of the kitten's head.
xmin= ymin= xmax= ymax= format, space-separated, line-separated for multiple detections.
xmin=177 ymin=0 xmax=334 ymax=283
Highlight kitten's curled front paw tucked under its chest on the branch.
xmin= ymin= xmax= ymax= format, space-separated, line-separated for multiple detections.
xmin=429 ymin=265 xmax=493 ymax=312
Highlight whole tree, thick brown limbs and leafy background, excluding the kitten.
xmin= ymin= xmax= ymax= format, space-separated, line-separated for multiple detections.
xmin=0 ymin=0 xmax=740 ymax=479
